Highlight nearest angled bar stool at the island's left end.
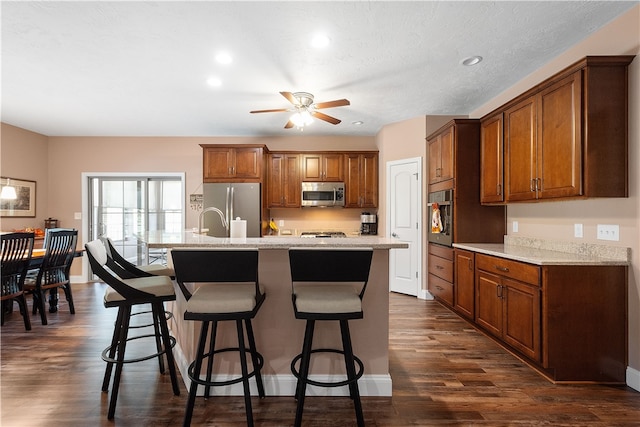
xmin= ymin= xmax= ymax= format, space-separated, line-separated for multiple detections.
xmin=85 ymin=240 xmax=180 ymax=419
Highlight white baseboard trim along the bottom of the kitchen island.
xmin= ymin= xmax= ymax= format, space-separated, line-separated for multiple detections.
xmin=173 ymin=344 xmax=392 ymax=397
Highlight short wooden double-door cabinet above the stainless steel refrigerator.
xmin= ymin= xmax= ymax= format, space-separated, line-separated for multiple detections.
xmin=201 ymin=144 xmax=266 ymax=182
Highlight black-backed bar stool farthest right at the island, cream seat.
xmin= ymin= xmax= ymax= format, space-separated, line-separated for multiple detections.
xmin=289 ymin=248 xmax=373 ymax=426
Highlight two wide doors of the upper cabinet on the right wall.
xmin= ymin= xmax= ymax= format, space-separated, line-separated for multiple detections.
xmin=505 ymin=71 xmax=582 ymax=201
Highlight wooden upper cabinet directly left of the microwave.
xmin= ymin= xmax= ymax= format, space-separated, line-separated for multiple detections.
xmin=267 ymin=153 xmax=302 ymax=208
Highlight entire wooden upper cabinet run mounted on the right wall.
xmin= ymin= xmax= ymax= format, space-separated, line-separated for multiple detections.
xmin=481 ymin=55 xmax=634 ymax=204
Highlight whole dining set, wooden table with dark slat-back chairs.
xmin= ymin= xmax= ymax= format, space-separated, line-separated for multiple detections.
xmin=0 ymin=228 xmax=83 ymax=331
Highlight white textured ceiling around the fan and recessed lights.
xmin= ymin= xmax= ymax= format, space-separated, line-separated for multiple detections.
xmin=1 ymin=1 xmax=638 ymax=136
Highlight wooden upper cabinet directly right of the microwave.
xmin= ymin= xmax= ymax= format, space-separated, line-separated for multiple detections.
xmin=345 ymin=152 xmax=378 ymax=208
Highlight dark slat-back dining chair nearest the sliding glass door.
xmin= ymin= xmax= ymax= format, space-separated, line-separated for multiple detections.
xmin=24 ymin=229 xmax=78 ymax=325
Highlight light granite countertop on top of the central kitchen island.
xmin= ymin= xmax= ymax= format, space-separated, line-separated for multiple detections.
xmin=138 ymin=230 xmax=409 ymax=249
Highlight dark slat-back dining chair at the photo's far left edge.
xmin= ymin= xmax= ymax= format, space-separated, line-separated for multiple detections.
xmin=0 ymin=233 xmax=35 ymax=331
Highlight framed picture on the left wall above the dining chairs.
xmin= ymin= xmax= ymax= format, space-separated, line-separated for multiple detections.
xmin=0 ymin=177 xmax=36 ymax=218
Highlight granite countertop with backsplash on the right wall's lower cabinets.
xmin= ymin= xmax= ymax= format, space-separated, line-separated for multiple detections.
xmin=453 ymin=236 xmax=631 ymax=265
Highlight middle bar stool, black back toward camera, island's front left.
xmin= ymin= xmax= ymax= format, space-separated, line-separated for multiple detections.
xmin=171 ymin=248 xmax=265 ymax=426
